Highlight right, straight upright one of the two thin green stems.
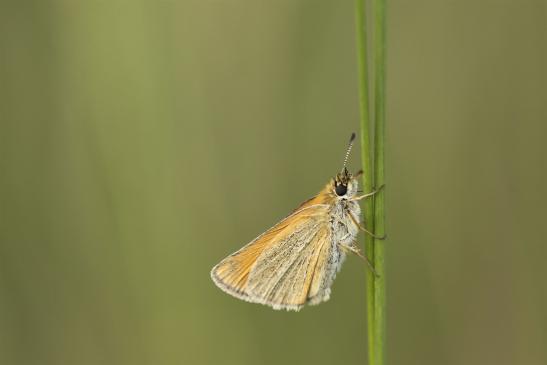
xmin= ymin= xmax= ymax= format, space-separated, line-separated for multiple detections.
xmin=373 ymin=0 xmax=386 ymax=365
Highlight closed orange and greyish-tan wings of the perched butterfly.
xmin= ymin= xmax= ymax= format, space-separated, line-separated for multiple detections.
xmin=211 ymin=197 xmax=340 ymax=310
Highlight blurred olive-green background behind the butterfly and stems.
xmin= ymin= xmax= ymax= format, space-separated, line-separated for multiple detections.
xmin=0 ymin=0 xmax=547 ymax=365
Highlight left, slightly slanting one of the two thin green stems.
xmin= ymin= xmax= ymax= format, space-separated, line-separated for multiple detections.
xmin=355 ymin=0 xmax=375 ymax=364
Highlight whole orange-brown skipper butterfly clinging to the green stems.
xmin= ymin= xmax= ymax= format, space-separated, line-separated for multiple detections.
xmin=211 ymin=133 xmax=376 ymax=311
